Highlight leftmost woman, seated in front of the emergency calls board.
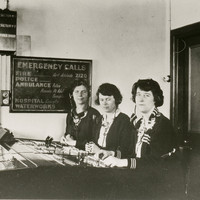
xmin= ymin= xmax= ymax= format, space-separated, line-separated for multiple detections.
xmin=60 ymin=80 xmax=100 ymax=150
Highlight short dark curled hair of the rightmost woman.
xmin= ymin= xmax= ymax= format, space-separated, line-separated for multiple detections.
xmin=131 ymin=79 xmax=164 ymax=107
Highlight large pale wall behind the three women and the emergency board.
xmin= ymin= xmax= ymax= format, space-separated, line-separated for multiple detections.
xmin=1 ymin=0 xmax=170 ymax=139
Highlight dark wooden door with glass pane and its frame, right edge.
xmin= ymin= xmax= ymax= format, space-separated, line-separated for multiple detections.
xmin=171 ymin=23 xmax=200 ymax=147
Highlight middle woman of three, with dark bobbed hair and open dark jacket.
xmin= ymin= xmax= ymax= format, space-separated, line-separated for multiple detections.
xmin=86 ymin=83 xmax=132 ymax=158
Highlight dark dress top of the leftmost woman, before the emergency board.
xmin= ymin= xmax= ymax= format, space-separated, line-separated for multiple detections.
xmin=65 ymin=107 xmax=100 ymax=150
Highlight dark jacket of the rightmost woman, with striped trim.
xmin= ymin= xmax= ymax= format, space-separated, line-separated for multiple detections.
xmin=129 ymin=109 xmax=177 ymax=167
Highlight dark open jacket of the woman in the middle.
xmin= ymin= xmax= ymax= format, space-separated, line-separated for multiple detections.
xmin=93 ymin=113 xmax=132 ymax=158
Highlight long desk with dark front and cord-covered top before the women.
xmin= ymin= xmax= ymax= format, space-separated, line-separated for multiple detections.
xmin=0 ymin=139 xmax=185 ymax=200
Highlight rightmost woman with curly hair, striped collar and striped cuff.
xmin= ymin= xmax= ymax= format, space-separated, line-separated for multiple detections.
xmin=101 ymin=79 xmax=176 ymax=169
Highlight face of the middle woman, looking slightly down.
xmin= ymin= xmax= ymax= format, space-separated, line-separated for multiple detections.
xmin=99 ymin=93 xmax=116 ymax=113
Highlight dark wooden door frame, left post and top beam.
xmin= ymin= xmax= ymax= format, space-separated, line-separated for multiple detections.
xmin=170 ymin=22 xmax=200 ymax=146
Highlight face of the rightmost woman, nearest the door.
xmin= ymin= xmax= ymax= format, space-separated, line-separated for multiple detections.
xmin=135 ymin=88 xmax=155 ymax=114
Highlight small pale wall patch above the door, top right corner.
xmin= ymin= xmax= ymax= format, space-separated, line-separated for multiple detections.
xmin=171 ymin=0 xmax=200 ymax=29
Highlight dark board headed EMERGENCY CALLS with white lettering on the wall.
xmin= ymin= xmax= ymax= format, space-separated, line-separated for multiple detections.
xmin=10 ymin=56 xmax=92 ymax=113
